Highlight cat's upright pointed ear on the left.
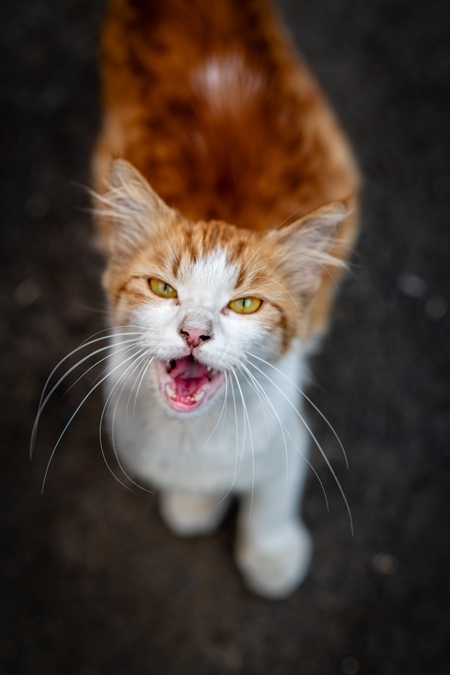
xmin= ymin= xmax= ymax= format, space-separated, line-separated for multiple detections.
xmin=106 ymin=159 xmax=175 ymax=259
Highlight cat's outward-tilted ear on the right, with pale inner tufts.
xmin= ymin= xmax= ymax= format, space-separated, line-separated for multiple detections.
xmin=274 ymin=202 xmax=349 ymax=295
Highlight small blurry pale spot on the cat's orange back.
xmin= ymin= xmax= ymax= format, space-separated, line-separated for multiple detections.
xmin=191 ymin=54 xmax=263 ymax=113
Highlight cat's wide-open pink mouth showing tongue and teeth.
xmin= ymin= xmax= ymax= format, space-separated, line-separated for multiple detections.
xmin=156 ymin=356 xmax=224 ymax=412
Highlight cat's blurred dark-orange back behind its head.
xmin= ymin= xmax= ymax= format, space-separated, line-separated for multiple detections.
xmin=95 ymin=0 xmax=358 ymax=230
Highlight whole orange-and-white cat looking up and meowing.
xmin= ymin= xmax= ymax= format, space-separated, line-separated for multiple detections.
xmin=86 ymin=0 xmax=360 ymax=599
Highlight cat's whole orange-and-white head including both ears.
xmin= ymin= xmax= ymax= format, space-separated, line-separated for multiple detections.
xmin=98 ymin=160 xmax=346 ymax=417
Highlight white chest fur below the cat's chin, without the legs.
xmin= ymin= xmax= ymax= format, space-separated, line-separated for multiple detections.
xmin=108 ymin=336 xmax=305 ymax=494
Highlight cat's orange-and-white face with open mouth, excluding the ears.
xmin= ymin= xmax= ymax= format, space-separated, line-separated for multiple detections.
xmin=110 ymin=222 xmax=298 ymax=413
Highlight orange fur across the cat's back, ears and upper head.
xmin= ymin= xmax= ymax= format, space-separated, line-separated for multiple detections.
xmin=94 ymin=0 xmax=359 ymax=345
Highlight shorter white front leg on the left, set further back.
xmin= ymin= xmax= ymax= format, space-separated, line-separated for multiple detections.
xmin=160 ymin=490 xmax=229 ymax=537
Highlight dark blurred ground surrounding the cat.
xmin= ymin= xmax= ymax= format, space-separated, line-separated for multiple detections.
xmin=0 ymin=0 xmax=450 ymax=675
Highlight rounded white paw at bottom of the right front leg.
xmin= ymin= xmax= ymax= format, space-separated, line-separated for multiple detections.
xmin=236 ymin=524 xmax=312 ymax=600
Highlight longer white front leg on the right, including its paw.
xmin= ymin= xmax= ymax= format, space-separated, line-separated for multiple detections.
xmin=236 ymin=454 xmax=312 ymax=599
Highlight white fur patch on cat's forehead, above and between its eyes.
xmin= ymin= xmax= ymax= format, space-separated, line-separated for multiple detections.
xmin=178 ymin=247 xmax=238 ymax=305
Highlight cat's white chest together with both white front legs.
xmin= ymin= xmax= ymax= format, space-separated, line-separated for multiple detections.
xmin=103 ymin=336 xmax=312 ymax=598
